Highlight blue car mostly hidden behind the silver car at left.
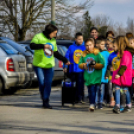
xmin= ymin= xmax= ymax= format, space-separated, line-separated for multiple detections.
xmin=0 ymin=37 xmax=34 ymax=88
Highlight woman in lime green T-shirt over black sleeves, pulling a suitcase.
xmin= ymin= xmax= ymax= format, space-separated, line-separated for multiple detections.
xmin=30 ymin=24 xmax=70 ymax=109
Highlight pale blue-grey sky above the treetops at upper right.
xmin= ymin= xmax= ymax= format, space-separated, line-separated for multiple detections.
xmin=70 ymin=0 xmax=134 ymax=26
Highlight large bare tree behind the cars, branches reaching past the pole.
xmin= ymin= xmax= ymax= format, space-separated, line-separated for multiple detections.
xmin=0 ymin=0 xmax=91 ymax=41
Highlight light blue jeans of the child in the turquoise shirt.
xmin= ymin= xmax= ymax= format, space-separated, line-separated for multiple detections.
xmin=95 ymin=83 xmax=105 ymax=104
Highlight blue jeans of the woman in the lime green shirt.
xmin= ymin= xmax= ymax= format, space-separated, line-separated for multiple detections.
xmin=34 ymin=67 xmax=54 ymax=100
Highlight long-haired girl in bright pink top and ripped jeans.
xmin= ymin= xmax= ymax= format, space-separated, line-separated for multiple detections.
xmin=112 ymin=36 xmax=132 ymax=114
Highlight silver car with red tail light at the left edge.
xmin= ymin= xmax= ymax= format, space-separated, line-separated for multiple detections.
xmin=0 ymin=40 xmax=30 ymax=93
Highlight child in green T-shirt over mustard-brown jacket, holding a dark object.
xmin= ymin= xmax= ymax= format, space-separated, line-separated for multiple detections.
xmin=79 ymin=38 xmax=104 ymax=111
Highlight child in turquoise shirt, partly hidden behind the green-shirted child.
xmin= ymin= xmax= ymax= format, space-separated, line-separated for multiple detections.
xmin=96 ymin=38 xmax=109 ymax=109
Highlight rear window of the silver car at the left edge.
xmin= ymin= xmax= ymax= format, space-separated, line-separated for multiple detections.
xmin=0 ymin=43 xmax=18 ymax=55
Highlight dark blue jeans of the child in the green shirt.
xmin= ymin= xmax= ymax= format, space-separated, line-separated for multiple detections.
xmin=88 ymin=84 xmax=100 ymax=105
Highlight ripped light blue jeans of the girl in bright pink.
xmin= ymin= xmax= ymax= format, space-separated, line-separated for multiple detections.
xmin=115 ymin=85 xmax=131 ymax=107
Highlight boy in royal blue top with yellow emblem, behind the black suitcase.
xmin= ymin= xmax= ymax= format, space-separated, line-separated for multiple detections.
xmin=63 ymin=32 xmax=86 ymax=103
